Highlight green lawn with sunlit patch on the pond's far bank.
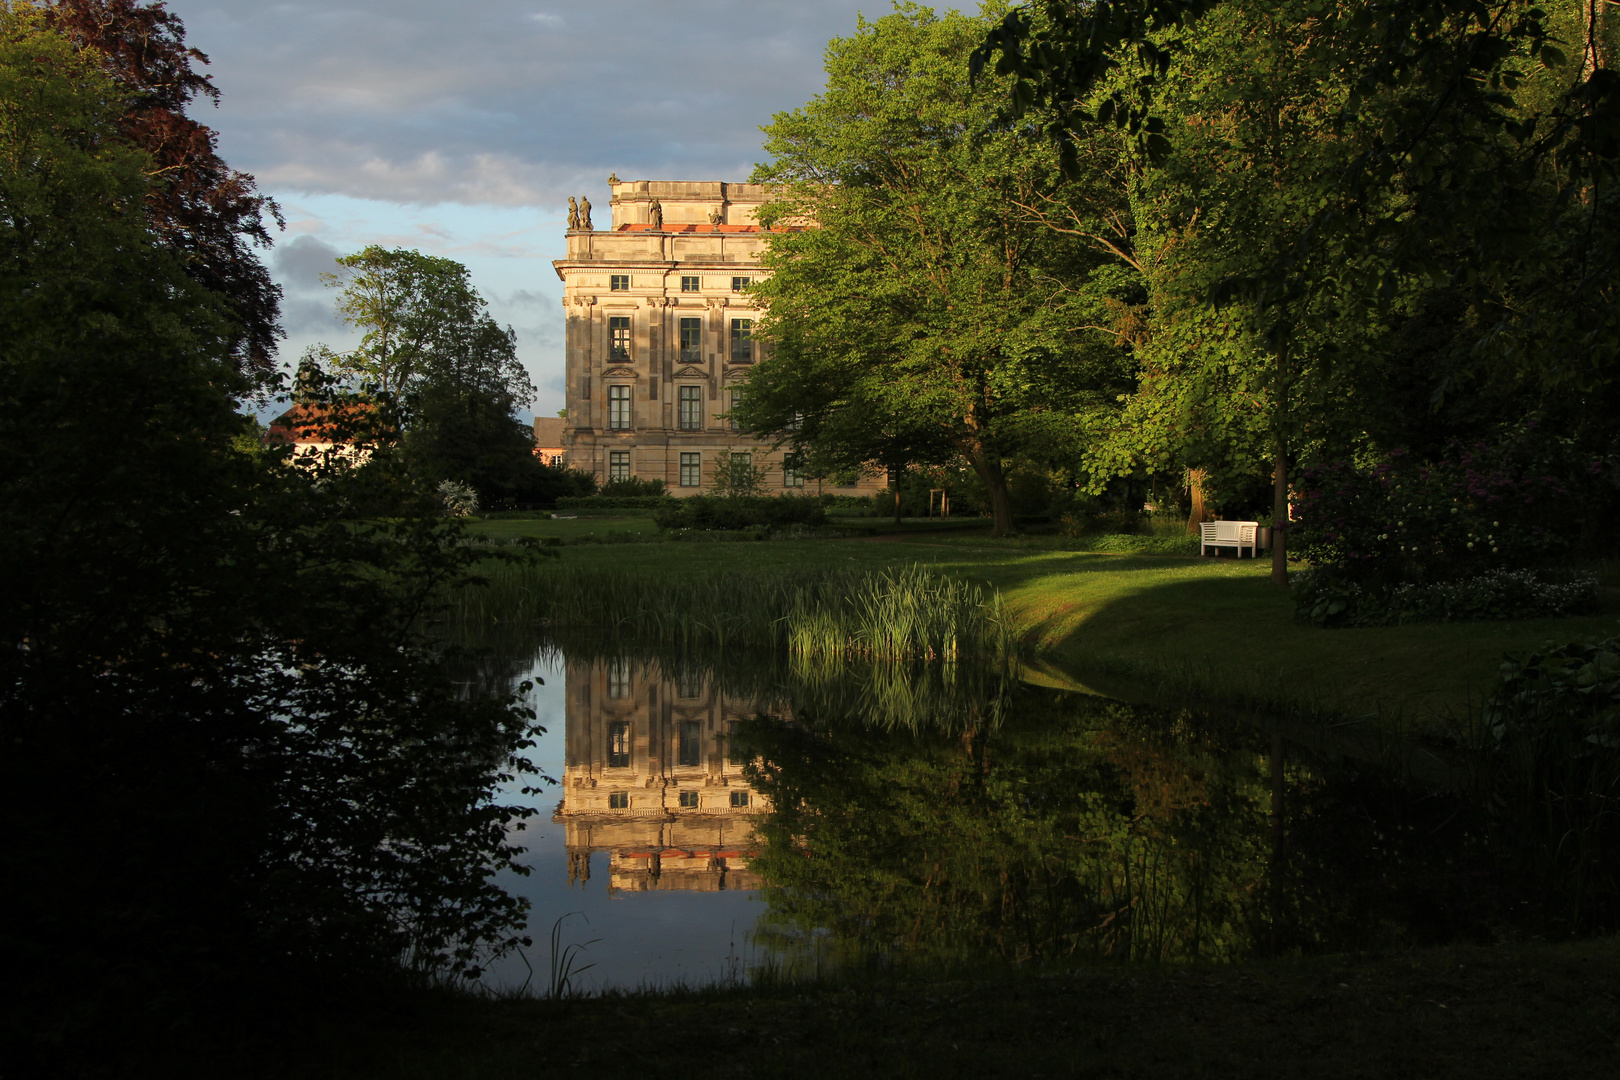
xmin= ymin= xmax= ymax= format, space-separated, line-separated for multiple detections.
xmin=537 ymin=537 xmax=1617 ymax=730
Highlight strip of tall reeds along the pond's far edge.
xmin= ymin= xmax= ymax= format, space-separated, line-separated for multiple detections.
xmin=447 ymin=562 xmax=1017 ymax=661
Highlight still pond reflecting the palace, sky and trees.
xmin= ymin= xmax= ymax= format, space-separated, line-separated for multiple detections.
xmin=463 ymin=641 xmax=1615 ymax=993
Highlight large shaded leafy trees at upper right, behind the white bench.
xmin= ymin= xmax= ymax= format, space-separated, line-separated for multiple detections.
xmin=974 ymin=0 xmax=1620 ymax=583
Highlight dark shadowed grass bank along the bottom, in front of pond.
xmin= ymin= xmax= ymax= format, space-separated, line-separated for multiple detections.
xmin=154 ymin=939 xmax=1620 ymax=1080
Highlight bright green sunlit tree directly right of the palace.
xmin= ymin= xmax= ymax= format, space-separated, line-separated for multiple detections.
xmin=737 ymin=5 xmax=1132 ymax=534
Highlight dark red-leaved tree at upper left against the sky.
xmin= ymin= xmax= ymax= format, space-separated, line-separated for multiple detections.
xmin=42 ymin=0 xmax=282 ymax=379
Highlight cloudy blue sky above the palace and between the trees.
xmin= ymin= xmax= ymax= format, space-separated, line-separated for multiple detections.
xmin=179 ymin=0 xmax=889 ymax=416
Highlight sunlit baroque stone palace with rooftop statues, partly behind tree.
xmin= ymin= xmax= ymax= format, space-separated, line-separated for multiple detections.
xmin=552 ymin=176 xmax=883 ymax=495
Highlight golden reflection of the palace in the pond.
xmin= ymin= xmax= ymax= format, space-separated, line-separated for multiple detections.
xmin=554 ymin=659 xmax=766 ymax=891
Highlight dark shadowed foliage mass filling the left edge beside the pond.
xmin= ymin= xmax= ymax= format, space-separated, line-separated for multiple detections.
xmin=0 ymin=6 xmax=530 ymax=1055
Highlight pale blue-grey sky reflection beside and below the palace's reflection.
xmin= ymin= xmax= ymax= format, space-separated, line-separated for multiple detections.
xmin=486 ymin=653 xmax=765 ymax=993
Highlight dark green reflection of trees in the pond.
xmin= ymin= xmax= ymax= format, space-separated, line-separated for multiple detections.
xmin=744 ymin=688 xmax=1594 ymax=963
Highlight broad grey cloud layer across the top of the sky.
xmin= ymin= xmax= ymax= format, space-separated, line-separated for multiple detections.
xmin=189 ymin=0 xmax=881 ymax=207
